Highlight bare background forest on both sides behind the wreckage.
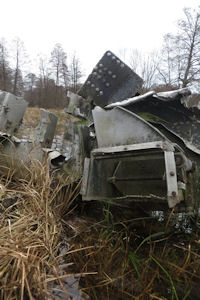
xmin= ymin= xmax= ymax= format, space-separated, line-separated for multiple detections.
xmin=0 ymin=7 xmax=200 ymax=108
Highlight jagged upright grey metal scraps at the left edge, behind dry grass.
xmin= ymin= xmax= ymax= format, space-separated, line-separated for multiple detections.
xmin=0 ymin=91 xmax=64 ymax=167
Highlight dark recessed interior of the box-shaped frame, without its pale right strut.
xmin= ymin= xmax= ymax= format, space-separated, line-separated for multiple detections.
xmin=81 ymin=141 xmax=178 ymax=205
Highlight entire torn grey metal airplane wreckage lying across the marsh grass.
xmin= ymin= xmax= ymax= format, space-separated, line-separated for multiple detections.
xmin=0 ymin=51 xmax=200 ymax=212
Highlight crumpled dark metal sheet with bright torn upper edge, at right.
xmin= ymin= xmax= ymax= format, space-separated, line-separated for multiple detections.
xmin=106 ymin=88 xmax=200 ymax=154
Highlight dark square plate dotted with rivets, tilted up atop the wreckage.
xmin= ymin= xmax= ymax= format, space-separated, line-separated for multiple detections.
xmin=78 ymin=51 xmax=143 ymax=107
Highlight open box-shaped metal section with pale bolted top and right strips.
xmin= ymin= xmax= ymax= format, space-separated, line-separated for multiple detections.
xmin=81 ymin=141 xmax=187 ymax=210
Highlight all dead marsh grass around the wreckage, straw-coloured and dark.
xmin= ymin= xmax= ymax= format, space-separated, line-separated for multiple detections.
xmin=0 ymin=108 xmax=200 ymax=300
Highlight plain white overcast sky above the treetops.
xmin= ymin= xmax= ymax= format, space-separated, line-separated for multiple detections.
xmin=0 ymin=0 xmax=199 ymax=75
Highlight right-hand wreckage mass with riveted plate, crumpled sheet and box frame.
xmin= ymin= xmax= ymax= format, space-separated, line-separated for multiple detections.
xmin=78 ymin=51 xmax=200 ymax=211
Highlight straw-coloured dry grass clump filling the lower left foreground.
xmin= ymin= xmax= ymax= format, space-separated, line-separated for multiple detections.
xmin=0 ymin=158 xmax=83 ymax=300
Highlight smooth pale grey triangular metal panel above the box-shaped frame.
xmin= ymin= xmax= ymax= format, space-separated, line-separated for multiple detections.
xmin=93 ymin=107 xmax=167 ymax=147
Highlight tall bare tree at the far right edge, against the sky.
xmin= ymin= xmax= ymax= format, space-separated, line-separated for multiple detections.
xmin=159 ymin=7 xmax=200 ymax=87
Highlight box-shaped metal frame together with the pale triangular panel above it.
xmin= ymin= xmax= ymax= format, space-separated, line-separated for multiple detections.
xmin=82 ymin=107 xmax=192 ymax=207
